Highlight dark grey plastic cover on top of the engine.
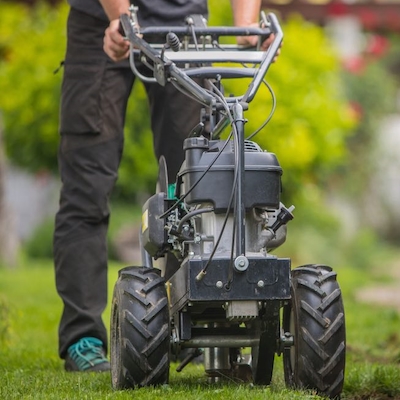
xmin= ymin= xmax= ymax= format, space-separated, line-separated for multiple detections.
xmin=177 ymin=137 xmax=282 ymax=213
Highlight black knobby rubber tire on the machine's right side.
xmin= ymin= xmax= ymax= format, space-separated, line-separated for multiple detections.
xmin=283 ymin=265 xmax=346 ymax=398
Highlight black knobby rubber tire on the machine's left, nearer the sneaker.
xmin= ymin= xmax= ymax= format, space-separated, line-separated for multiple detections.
xmin=110 ymin=267 xmax=170 ymax=389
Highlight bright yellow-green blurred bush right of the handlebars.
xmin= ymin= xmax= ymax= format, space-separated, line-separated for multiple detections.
xmin=264 ymin=18 xmax=355 ymax=198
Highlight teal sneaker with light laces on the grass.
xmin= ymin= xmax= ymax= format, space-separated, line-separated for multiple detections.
xmin=65 ymin=337 xmax=110 ymax=372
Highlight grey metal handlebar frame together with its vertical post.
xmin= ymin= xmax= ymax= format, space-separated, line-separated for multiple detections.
xmin=120 ymin=10 xmax=283 ymax=257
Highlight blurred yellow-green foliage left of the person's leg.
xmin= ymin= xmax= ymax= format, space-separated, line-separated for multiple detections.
xmin=0 ymin=2 xmax=67 ymax=171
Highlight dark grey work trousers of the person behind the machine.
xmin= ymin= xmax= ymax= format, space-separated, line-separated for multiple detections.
xmin=54 ymin=9 xmax=200 ymax=358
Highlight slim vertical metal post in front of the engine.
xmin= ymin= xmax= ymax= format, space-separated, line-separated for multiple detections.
xmin=232 ymin=103 xmax=246 ymax=257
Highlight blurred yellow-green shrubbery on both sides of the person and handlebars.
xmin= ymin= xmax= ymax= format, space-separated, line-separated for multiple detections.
xmin=0 ymin=0 xmax=354 ymax=203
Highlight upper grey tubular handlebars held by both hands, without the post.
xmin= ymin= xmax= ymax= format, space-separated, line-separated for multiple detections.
xmin=120 ymin=13 xmax=283 ymax=105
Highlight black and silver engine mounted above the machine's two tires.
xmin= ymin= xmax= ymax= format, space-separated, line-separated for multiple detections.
xmin=142 ymin=136 xmax=293 ymax=260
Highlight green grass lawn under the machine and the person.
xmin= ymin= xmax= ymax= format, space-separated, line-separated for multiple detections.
xmin=0 ymin=260 xmax=400 ymax=400
